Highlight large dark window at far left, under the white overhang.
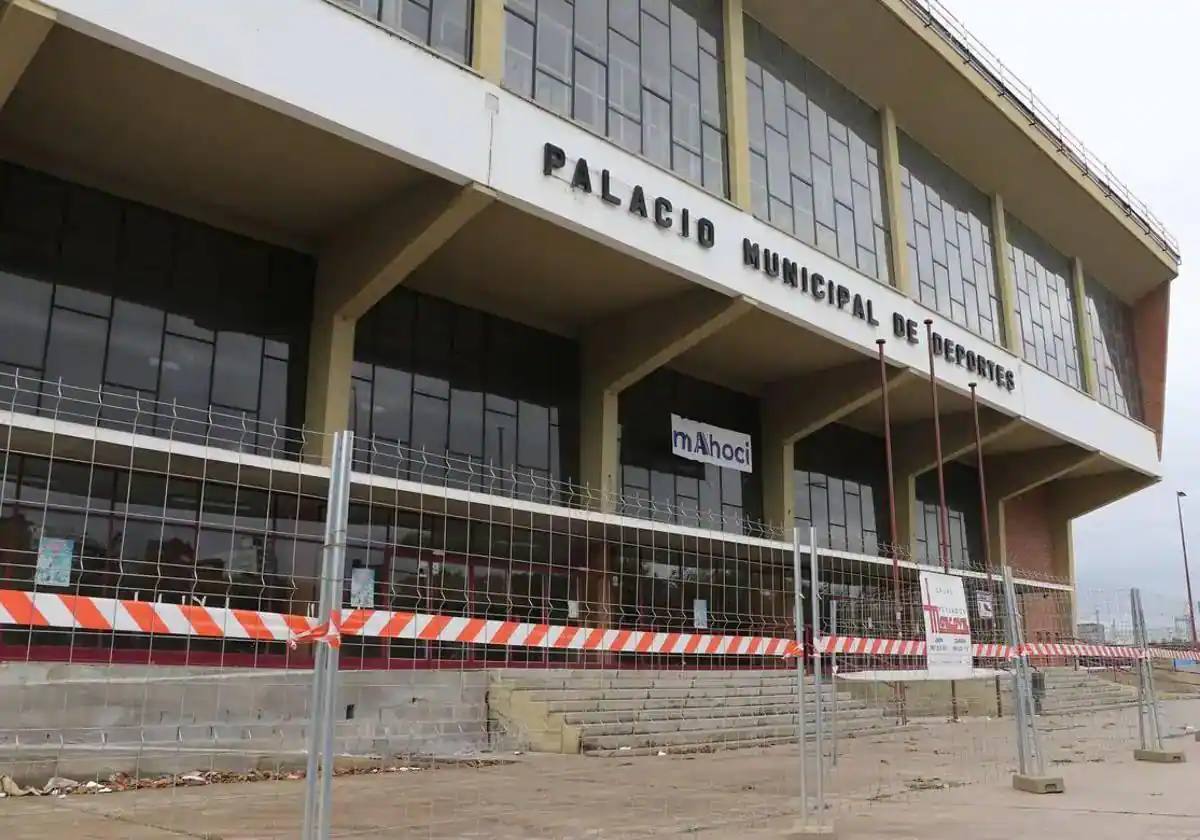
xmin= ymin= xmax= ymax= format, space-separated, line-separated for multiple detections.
xmin=0 ymin=163 xmax=313 ymax=456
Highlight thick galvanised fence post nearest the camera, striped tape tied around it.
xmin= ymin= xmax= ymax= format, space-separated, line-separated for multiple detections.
xmin=302 ymin=432 xmax=354 ymax=840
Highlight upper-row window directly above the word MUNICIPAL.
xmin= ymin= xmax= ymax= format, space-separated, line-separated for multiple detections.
xmin=745 ymin=17 xmax=890 ymax=282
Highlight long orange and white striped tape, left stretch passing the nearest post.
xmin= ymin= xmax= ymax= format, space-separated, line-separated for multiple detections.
xmin=0 ymin=589 xmax=799 ymax=656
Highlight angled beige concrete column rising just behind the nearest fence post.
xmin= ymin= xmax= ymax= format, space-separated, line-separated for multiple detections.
xmin=305 ymin=180 xmax=493 ymax=457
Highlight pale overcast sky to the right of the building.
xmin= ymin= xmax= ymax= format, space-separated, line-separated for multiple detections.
xmin=942 ymin=0 xmax=1200 ymax=623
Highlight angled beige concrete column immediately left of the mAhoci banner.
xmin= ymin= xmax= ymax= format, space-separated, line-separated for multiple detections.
xmin=580 ymin=289 xmax=754 ymax=511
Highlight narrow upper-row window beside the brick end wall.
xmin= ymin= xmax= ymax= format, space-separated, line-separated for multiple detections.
xmin=1085 ymin=277 xmax=1142 ymax=420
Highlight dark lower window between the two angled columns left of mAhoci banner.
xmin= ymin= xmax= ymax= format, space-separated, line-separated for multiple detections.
xmin=350 ymin=288 xmax=578 ymax=500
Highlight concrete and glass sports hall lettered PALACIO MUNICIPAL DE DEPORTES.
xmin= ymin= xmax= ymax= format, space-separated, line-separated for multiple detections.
xmin=0 ymin=0 xmax=1180 ymax=662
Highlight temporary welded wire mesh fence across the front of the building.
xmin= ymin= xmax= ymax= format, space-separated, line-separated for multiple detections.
xmin=0 ymin=380 xmax=1196 ymax=838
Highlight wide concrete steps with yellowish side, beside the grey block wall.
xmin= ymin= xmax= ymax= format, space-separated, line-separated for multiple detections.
xmin=488 ymin=671 xmax=893 ymax=756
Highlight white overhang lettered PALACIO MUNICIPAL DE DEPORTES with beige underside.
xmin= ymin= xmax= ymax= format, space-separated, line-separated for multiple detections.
xmin=0 ymin=0 xmax=1165 ymax=476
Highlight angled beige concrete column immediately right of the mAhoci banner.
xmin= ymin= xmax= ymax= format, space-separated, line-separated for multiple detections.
xmin=760 ymin=360 xmax=913 ymax=528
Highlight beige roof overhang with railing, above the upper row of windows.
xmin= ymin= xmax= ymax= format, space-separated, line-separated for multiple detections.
xmin=745 ymin=0 xmax=1178 ymax=302
